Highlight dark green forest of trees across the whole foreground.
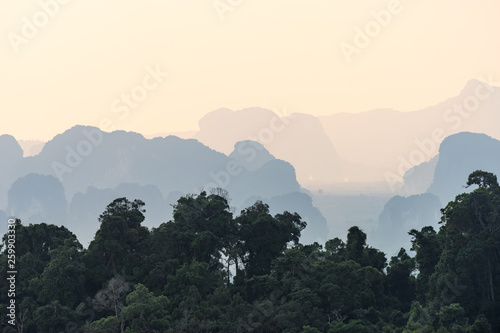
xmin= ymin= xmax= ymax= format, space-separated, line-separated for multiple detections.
xmin=0 ymin=170 xmax=500 ymax=333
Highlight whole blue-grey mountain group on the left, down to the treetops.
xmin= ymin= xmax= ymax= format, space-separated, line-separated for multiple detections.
xmin=0 ymin=126 xmax=327 ymax=244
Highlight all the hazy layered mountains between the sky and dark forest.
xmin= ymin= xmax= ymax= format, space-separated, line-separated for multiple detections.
xmin=0 ymin=80 xmax=500 ymax=251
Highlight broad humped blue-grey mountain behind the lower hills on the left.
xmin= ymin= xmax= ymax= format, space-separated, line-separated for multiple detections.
xmin=12 ymin=126 xmax=227 ymax=200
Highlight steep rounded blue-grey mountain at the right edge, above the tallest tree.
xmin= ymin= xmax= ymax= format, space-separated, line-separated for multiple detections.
xmin=428 ymin=131 xmax=500 ymax=205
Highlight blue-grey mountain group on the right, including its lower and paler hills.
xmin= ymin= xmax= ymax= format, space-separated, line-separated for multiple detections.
xmin=373 ymin=132 xmax=500 ymax=253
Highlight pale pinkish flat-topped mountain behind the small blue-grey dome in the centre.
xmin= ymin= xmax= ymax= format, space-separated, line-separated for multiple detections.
xmin=194 ymin=108 xmax=344 ymax=185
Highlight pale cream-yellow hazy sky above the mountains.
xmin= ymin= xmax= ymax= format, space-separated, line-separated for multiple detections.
xmin=0 ymin=0 xmax=500 ymax=140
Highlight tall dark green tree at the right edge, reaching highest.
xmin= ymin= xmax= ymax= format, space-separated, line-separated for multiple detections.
xmin=429 ymin=171 xmax=500 ymax=329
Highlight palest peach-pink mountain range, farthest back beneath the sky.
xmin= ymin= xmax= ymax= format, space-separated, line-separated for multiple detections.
xmin=150 ymin=80 xmax=500 ymax=189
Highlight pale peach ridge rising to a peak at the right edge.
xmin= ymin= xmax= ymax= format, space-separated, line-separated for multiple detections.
xmin=319 ymin=80 xmax=500 ymax=185
